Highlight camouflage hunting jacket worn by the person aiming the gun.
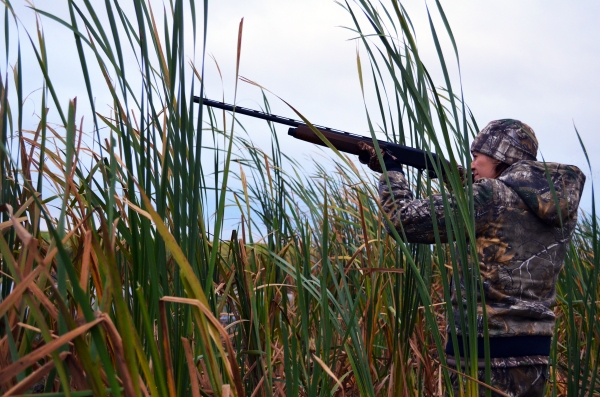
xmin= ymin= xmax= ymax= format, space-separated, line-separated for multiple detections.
xmin=379 ymin=161 xmax=585 ymax=337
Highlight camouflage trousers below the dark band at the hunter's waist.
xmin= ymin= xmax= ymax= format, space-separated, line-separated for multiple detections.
xmin=450 ymin=364 xmax=548 ymax=397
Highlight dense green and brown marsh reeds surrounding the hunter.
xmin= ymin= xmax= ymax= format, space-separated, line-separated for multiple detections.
xmin=0 ymin=0 xmax=600 ymax=396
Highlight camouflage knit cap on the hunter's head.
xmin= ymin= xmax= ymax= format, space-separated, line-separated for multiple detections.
xmin=471 ymin=119 xmax=538 ymax=165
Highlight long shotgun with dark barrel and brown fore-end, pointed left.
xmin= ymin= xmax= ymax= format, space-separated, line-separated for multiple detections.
xmin=194 ymin=96 xmax=445 ymax=178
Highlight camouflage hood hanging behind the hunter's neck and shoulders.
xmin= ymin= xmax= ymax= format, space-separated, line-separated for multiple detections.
xmin=498 ymin=161 xmax=585 ymax=227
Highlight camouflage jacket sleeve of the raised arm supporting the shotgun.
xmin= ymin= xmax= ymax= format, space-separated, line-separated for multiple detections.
xmin=378 ymin=171 xmax=493 ymax=244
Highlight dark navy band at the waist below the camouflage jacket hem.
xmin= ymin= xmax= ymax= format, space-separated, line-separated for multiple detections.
xmin=446 ymin=335 xmax=552 ymax=358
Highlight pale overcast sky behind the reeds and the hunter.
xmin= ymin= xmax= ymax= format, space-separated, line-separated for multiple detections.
xmin=2 ymin=0 xmax=600 ymax=209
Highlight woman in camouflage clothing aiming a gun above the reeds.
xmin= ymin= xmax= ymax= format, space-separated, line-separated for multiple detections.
xmin=360 ymin=119 xmax=585 ymax=396
